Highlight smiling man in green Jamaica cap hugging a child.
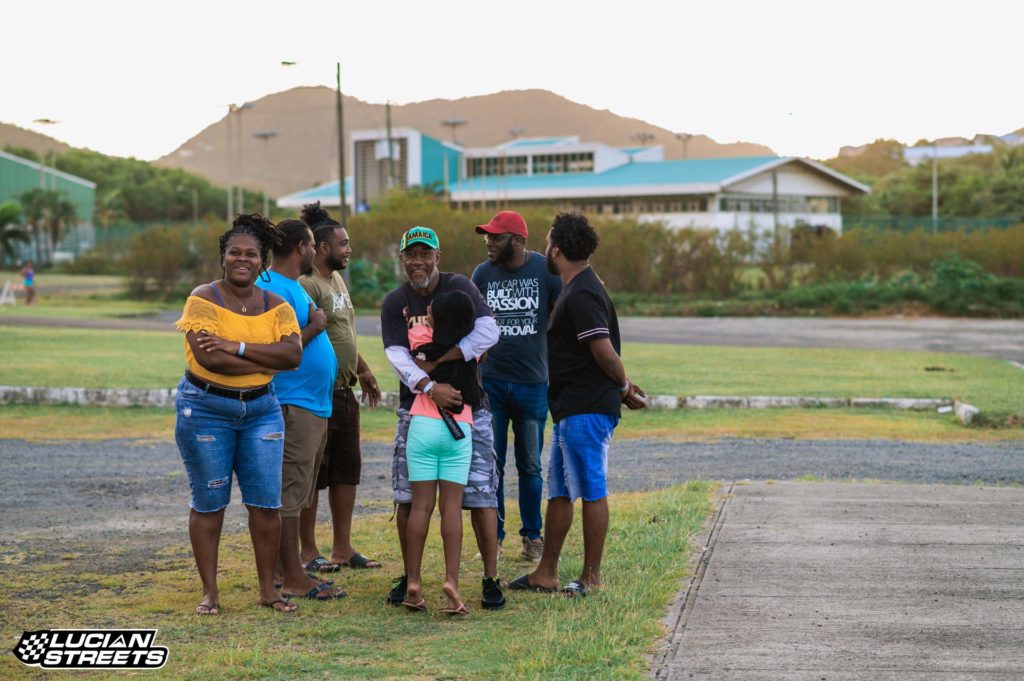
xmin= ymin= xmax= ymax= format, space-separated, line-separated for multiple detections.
xmin=381 ymin=227 xmax=505 ymax=609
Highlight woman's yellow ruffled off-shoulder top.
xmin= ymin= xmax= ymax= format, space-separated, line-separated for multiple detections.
xmin=174 ymin=296 xmax=300 ymax=388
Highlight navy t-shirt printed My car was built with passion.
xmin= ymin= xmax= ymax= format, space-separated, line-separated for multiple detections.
xmin=473 ymin=251 xmax=562 ymax=383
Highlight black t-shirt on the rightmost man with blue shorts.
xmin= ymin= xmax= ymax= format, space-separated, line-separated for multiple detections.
xmin=548 ymin=267 xmax=622 ymax=423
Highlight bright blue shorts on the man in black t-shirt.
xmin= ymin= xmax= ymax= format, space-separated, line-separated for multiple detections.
xmin=548 ymin=414 xmax=618 ymax=502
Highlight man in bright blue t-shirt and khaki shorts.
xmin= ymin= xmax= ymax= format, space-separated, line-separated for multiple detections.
xmin=256 ymin=220 xmax=345 ymax=600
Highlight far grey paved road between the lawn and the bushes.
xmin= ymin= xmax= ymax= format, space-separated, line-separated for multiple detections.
xmin=0 ymin=308 xmax=1024 ymax=361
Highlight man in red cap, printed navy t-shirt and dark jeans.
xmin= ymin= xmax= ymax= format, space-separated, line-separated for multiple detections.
xmin=473 ymin=211 xmax=562 ymax=562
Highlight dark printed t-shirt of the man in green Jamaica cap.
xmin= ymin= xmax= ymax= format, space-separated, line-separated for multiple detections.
xmin=381 ymin=272 xmax=492 ymax=409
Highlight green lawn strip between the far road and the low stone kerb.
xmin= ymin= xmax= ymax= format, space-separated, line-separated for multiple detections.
xmin=0 ymin=327 xmax=1024 ymax=415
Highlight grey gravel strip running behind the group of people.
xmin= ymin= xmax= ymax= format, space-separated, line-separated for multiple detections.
xmin=0 ymin=439 xmax=1024 ymax=571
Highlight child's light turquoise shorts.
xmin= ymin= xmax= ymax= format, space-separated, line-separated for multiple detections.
xmin=406 ymin=416 xmax=473 ymax=485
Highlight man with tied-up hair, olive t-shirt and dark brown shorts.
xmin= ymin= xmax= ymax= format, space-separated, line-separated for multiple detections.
xmin=299 ymin=202 xmax=381 ymax=571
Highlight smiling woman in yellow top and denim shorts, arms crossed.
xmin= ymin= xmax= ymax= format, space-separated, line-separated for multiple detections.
xmin=174 ymin=215 xmax=302 ymax=615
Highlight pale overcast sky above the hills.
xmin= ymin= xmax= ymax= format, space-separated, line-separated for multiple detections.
xmin=0 ymin=0 xmax=1024 ymax=159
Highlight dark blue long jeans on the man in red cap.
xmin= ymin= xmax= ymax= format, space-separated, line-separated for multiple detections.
xmin=483 ymin=378 xmax=548 ymax=540
